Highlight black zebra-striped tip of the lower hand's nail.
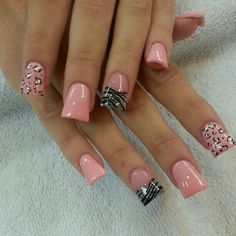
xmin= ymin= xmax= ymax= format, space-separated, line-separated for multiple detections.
xmin=136 ymin=179 xmax=164 ymax=206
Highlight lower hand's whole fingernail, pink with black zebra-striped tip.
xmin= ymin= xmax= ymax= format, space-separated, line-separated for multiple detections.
xmin=130 ymin=168 xmax=164 ymax=206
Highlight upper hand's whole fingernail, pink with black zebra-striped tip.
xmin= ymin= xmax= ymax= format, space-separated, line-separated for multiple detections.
xmin=101 ymin=72 xmax=129 ymax=111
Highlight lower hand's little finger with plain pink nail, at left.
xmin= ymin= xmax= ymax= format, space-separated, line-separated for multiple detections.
xmin=29 ymin=85 xmax=105 ymax=185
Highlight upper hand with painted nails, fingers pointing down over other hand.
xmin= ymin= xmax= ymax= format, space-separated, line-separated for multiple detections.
xmin=16 ymin=0 xmax=192 ymax=122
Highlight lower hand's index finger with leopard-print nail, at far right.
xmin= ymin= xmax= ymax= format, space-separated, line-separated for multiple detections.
xmin=141 ymin=65 xmax=236 ymax=157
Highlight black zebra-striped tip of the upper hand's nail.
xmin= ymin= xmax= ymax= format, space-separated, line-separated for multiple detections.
xmin=101 ymin=87 xmax=127 ymax=111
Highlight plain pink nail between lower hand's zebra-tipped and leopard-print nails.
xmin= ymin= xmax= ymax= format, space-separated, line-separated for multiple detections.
xmin=172 ymin=161 xmax=207 ymax=198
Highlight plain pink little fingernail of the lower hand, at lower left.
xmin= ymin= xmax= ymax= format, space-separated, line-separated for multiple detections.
xmin=79 ymin=154 xmax=105 ymax=185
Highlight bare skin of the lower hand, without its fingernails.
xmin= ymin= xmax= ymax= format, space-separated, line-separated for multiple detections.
xmin=0 ymin=1 xmax=223 ymax=194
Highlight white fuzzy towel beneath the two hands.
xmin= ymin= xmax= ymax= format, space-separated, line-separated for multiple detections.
xmin=0 ymin=0 xmax=236 ymax=236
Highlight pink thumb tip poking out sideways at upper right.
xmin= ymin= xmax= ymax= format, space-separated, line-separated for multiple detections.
xmin=173 ymin=12 xmax=205 ymax=42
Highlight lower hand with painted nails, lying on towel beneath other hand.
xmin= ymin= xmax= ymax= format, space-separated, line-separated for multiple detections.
xmin=0 ymin=0 xmax=235 ymax=205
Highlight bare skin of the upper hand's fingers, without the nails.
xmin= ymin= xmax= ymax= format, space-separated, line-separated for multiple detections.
xmin=20 ymin=0 xmax=174 ymax=109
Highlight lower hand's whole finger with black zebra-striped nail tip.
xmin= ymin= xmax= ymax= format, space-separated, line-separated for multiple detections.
xmin=79 ymin=98 xmax=163 ymax=205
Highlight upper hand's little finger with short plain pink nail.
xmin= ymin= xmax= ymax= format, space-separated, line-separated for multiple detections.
xmin=145 ymin=0 xmax=174 ymax=70
